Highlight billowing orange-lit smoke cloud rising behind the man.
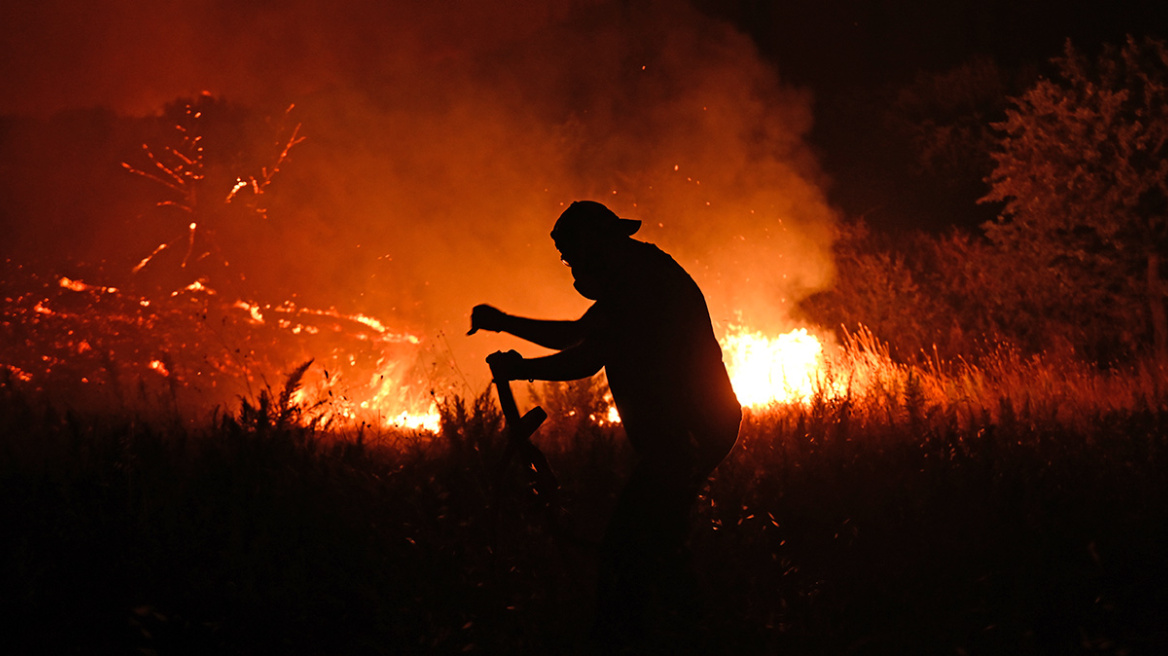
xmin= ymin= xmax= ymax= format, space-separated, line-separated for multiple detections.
xmin=0 ymin=0 xmax=834 ymax=385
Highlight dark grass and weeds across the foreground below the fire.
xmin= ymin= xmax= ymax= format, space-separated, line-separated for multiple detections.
xmin=0 ymin=371 xmax=1168 ymax=654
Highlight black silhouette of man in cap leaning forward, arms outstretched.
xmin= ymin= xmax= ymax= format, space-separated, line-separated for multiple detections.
xmin=471 ymin=201 xmax=742 ymax=643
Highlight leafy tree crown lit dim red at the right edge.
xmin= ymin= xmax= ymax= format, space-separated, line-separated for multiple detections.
xmin=982 ymin=39 xmax=1168 ymax=361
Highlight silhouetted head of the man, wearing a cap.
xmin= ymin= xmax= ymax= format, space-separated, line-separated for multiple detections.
xmin=551 ymin=201 xmax=641 ymax=300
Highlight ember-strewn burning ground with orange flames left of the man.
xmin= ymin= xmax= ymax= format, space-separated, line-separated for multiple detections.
xmin=0 ymin=263 xmax=437 ymax=431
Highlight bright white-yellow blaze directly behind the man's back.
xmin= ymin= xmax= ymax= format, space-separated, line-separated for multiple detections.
xmin=722 ymin=326 xmax=823 ymax=406
